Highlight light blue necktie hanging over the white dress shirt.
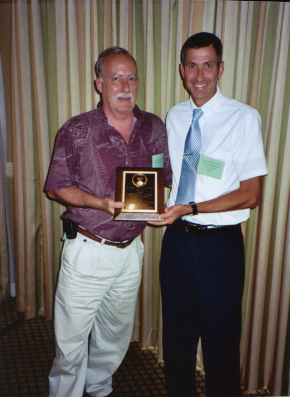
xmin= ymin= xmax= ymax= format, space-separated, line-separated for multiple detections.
xmin=175 ymin=109 xmax=203 ymax=204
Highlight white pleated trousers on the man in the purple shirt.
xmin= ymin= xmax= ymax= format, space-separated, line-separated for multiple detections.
xmin=49 ymin=233 xmax=144 ymax=397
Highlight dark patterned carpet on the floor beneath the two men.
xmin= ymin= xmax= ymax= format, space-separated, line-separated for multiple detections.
xmin=0 ymin=298 xmax=269 ymax=397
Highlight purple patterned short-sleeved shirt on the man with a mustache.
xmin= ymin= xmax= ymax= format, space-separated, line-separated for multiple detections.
xmin=44 ymin=103 xmax=171 ymax=241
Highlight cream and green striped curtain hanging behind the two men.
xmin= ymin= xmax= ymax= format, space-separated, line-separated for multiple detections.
xmin=0 ymin=0 xmax=290 ymax=395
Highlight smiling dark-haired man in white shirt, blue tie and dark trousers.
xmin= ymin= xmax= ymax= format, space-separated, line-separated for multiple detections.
xmin=151 ymin=32 xmax=267 ymax=397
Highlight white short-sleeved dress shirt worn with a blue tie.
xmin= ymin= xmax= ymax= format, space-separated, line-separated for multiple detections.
xmin=166 ymin=87 xmax=268 ymax=225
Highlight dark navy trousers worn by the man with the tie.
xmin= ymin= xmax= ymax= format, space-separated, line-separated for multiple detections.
xmin=160 ymin=222 xmax=245 ymax=397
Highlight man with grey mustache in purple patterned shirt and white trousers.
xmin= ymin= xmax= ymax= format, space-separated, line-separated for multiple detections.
xmin=45 ymin=47 xmax=171 ymax=397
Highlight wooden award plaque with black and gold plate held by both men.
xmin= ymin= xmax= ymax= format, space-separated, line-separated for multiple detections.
xmin=114 ymin=167 xmax=164 ymax=221
